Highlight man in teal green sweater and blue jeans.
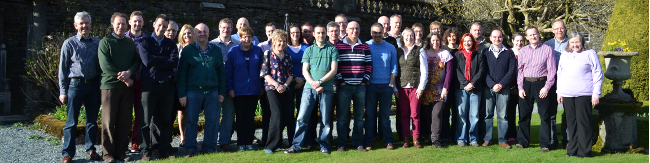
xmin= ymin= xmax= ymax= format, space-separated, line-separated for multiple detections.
xmin=176 ymin=23 xmax=226 ymax=158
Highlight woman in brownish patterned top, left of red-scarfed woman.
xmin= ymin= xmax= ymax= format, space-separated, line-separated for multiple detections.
xmin=422 ymin=33 xmax=454 ymax=148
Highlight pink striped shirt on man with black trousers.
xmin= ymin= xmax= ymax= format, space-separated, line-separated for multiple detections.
xmin=517 ymin=44 xmax=557 ymax=90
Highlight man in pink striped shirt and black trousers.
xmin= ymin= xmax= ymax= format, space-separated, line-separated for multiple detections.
xmin=515 ymin=27 xmax=557 ymax=152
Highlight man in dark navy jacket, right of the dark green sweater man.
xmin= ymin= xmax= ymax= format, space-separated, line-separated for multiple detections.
xmin=136 ymin=14 xmax=178 ymax=161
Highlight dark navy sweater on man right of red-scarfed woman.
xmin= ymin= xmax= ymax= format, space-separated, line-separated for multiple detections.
xmin=483 ymin=48 xmax=517 ymax=88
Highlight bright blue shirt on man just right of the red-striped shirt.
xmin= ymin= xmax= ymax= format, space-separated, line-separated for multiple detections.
xmin=366 ymin=40 xmax=398 ymax=84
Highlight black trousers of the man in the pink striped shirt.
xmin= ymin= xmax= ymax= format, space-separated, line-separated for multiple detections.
xmin=517 ymin=80 xmax=557 ymax=148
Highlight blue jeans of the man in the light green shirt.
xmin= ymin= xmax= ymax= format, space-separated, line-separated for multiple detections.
xmin=291 ymin=88 xmax=334 ymax=151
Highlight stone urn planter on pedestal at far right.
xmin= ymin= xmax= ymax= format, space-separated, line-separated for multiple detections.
xmin=594 ymin=51 xmax=643 ymax=152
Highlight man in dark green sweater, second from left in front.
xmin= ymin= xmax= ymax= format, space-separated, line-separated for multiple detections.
xmin=98 ymin=12 xmax=142 ymax=162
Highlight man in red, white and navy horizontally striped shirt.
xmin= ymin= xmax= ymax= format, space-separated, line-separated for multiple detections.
xmin=335 ymin=21 xmax=372 ymax=152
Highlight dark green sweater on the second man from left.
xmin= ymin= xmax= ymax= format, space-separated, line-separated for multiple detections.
xmin=97 ymin=35 xmax=142 ymax=89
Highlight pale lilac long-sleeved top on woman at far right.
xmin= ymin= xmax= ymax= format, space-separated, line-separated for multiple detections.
xmin=557 ymin=49 xmax=603 ymax=97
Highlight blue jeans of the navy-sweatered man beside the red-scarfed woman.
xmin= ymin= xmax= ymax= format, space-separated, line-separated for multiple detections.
xmin=483 ymin=87 xmax=510 ymax=143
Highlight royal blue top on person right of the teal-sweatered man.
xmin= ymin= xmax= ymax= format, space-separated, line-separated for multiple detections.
xmin=226 ymin=44 xmax=264 ymax=96
